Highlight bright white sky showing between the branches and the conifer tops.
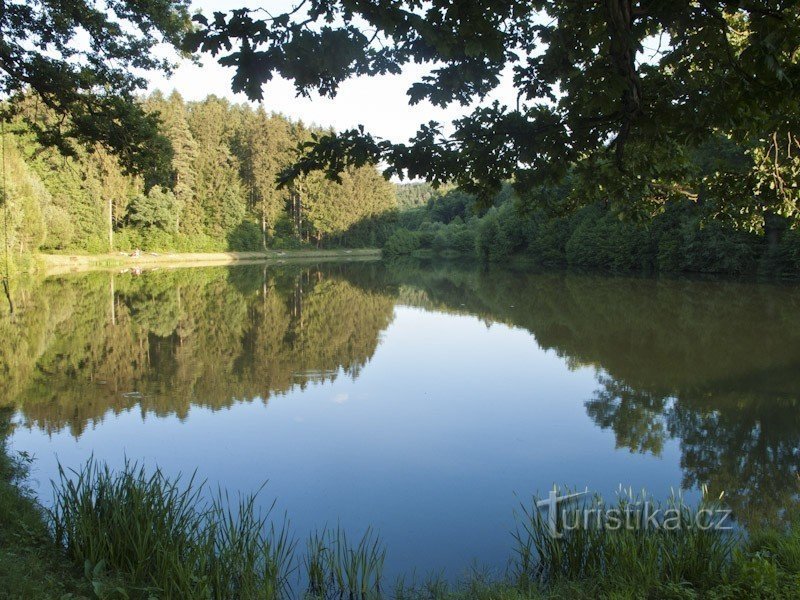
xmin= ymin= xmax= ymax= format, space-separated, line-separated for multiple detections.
xmin=148 ymin=0 xmax=515 ymax=142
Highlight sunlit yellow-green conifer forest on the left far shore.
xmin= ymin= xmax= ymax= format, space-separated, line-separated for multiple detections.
xmin=0 ymin=93 xmax=395 ymax=270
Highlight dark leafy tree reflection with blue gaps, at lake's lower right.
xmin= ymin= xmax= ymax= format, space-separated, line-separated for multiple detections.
xmin=586 ymin=376 xmax=800 ymax=523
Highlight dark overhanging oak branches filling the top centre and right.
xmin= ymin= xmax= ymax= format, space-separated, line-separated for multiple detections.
xmin=187 ymin=0 xmax=800 ymax=214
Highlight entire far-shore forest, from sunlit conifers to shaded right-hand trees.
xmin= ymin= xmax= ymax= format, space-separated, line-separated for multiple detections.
xmin=0 ymin=93 xmax=800 ymax=276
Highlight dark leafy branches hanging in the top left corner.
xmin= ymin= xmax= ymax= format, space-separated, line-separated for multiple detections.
xmin=0 ymin=0 xmax=190 ymax=183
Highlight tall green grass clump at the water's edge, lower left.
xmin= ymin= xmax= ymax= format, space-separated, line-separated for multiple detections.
xmin=50 ymin=460 xmax=294 ymax=599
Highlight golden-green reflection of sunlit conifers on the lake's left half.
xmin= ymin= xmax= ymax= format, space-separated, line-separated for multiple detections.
xmin=0 ymin=266 xmax=394 ymax=435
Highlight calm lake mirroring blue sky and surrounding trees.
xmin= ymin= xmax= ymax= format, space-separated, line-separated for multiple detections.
xmin=0 ymin=261 xmax=800 ymax=576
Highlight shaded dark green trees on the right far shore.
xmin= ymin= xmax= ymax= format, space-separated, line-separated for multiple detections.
xmin=384 ymin=182 xmax=800 ymax=277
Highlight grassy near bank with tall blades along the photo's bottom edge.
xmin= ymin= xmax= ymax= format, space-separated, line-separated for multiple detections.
xmin=0 ymin=419 xmax=800 ymax=600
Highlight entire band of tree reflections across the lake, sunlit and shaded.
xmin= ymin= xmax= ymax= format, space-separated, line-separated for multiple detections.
xmin=0 ymin=263 xmax=800 ymax=523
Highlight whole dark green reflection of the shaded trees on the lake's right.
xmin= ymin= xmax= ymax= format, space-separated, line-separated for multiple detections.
xmin=380 ymin=265 xmax=800 ymax=523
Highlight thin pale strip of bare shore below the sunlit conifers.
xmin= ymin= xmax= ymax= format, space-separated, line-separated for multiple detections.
xmin=37 ymin=248 xmax=381 ymax=275
